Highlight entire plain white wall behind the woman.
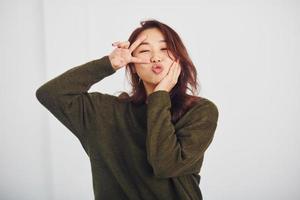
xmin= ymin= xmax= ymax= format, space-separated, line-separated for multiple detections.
xmin=0 ymin=0 xmax=300 ymax=200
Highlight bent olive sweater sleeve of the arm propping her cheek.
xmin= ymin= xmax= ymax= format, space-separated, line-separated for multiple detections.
xmin=146 ymin=90 xmax=218 ymax=178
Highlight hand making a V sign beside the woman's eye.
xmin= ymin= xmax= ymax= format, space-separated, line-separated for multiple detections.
xmin=108 ymin=35 xmax=150 ymax=70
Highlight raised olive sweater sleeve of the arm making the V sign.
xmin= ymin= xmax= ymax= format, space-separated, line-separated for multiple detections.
xmin=36 ymin=56 xmax=116 ymax=153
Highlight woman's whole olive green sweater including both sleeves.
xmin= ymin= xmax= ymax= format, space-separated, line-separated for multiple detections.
xmin=36 ymin=56 xmax=218 ymax=200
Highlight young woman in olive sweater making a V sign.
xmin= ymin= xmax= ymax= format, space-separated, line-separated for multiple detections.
xmin=36 ymin=20 xmax=218 ymax=200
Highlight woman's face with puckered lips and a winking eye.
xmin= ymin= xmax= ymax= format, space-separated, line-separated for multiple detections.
xmin=132 ymin=28 xmax=174 ymax=86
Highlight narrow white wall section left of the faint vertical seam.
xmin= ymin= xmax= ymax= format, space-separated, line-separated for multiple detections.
xmin=0 ymin=0 xmax=53 ymax=200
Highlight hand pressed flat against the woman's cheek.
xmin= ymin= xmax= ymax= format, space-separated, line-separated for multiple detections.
xmin=153 ymin=61 xmax=181 ymax=92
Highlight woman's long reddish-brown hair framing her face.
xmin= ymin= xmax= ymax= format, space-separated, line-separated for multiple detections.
xmin=118 ymin=19 xmax=201 ymax=123
